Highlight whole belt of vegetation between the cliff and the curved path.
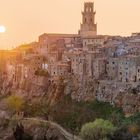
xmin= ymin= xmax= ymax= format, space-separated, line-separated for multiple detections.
xmin=0 ymin=95 xmax=140 ymax=140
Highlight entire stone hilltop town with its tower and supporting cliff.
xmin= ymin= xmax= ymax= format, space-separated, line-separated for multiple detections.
xmin=0 ymin=2 xmax=140 ymax=114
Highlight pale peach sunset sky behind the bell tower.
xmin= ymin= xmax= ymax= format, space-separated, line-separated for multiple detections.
xmin=0 ymin=0 xmax=140 ymax=49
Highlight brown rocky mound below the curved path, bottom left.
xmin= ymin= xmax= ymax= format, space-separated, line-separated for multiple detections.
xmin=0 ymin=121 xmax=67 ymax=140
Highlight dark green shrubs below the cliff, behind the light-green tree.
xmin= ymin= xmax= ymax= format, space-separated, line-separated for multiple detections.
xmin=50 ymin=95 xmax=124 ymax=134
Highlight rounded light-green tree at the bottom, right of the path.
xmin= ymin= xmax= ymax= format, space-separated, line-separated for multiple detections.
xmin=80 ymin=119 xmax=115 ymax=140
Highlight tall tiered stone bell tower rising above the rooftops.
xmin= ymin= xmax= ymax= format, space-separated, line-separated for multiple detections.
xmin=79 ymin=2 xmax=97 ymax=36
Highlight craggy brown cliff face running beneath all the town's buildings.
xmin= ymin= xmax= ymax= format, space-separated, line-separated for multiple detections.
xmin=0 ymin=72 xmax=140 ymax=114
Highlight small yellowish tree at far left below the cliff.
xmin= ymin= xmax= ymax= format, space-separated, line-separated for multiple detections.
xmin=7 ymin=95 xmax=24 ymax=112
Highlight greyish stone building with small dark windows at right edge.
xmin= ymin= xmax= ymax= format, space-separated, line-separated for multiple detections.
xmin=106 ymin=55 xmax=139 ymax=82
